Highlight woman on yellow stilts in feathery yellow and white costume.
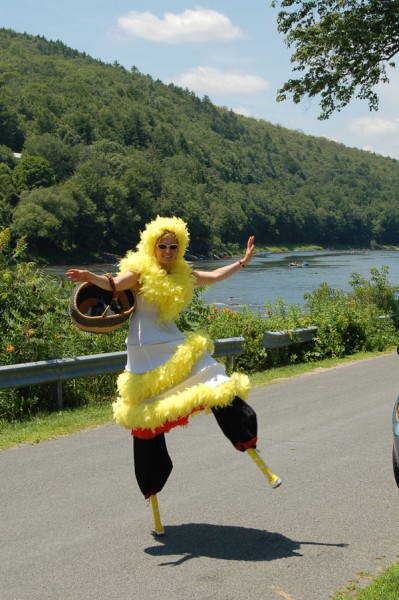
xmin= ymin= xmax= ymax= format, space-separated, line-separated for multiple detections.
xmin=67 ymin=217 xmax=281 ymax=535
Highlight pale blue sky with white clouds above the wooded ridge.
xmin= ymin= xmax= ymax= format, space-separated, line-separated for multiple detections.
xmin=0 ymin=0 xmax=399 ymax=159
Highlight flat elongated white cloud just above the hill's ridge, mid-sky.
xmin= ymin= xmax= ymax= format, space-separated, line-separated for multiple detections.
xmin=173 ymin=66 xmax=269 ymax=94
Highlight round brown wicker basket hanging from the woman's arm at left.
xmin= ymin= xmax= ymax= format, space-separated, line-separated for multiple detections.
xmin=69 ymin=277 xmax=136 ymax=333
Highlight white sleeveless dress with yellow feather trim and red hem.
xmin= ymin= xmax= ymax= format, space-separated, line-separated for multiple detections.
xmin=113 ymin=294 xmax=249 ymax=438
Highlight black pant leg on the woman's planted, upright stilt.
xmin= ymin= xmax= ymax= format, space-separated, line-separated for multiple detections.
xmin=133 ymin=433 xmax=173 ymax=498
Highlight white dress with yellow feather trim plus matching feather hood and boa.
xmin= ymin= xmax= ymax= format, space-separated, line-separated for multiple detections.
xmin=113 ymin=217 xmax=249 ymax=438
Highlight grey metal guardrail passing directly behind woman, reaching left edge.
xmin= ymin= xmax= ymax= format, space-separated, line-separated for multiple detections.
xmin=0 ymin=337 xmax=245 ymax=410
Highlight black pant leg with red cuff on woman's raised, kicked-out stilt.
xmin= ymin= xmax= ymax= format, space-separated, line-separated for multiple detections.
xmin=212 ymin=396 xmax=258 ymax=452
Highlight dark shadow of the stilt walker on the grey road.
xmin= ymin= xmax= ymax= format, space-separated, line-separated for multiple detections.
xmin=145 ymin=523 xmax=347 ymax=566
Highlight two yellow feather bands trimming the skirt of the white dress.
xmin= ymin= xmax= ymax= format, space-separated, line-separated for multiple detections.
xmin=112 ymin=334 xmax=249 ymax=431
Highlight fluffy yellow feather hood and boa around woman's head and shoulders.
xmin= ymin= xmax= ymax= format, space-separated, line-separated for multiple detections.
xmin=119 ymin=217 xmax=194 ymax=321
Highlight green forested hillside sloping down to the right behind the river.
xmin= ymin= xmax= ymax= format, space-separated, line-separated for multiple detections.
xmin=0 ymin=29 xmax=399 ymax=255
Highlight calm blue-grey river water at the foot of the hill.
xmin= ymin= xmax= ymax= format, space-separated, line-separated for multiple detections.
xmin=57 ymin=251 xmax=399 ymax=312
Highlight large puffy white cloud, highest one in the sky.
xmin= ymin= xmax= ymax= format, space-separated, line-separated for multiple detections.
xmin=117 ymin=6 xmax=244 ymax=44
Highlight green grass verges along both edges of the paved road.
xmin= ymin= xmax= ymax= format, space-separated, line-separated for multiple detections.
xmin=0 ymin=349 xmax=399 ymax=600
